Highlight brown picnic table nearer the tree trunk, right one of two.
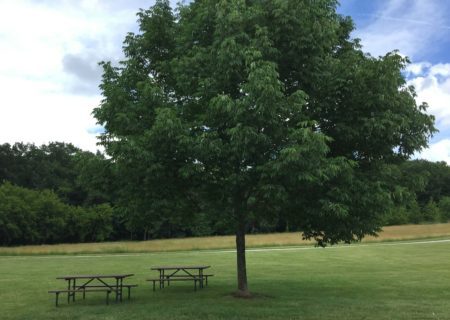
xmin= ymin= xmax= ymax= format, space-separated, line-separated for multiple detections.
xmin=147 ymin=265 xmax=213 ymax=291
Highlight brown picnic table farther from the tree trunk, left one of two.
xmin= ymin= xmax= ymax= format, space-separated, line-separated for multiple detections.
xmin=49 ymin=273 xmax=137 ymax=306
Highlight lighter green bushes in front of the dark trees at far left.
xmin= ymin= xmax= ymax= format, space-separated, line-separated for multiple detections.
xmin=0 ymin=182 xmax=112 ymax=245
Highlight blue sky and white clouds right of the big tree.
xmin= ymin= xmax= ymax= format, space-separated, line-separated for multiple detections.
xmin=338 ymin=0 xmax=450 ymax=164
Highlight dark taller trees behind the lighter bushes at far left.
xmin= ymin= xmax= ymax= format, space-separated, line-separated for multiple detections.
xmin=0 ymin=142 xmax=118 ymax=205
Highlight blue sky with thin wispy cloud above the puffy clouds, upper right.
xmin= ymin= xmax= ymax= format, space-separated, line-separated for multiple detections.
xmin=338 ymin=0 xmax=450 ymax=64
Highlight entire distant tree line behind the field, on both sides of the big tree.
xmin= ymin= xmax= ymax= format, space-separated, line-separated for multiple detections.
xmin=0 ymin=142 xmax=450 ymax=245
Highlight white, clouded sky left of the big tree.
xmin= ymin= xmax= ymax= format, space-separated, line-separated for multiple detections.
xmin=0 ymin=0 xmax=153 ymax=151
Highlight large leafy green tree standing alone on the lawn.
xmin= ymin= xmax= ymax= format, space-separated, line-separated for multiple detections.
xmin=94 ymin=0 xmax=435 ymax=296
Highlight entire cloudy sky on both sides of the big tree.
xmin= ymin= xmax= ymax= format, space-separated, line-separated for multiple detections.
xmin=0 ymin=0 xmax=450 ymax=164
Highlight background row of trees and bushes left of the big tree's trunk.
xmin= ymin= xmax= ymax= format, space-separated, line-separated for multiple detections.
xmin=0 ymin=142 xmax=236 ymax=245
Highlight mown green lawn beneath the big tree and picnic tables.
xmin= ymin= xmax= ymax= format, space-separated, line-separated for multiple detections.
xmin=0 ymin=242 xmax=450 ymax=320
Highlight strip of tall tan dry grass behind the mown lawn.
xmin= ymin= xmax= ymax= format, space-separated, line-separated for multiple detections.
xmin=0 ymin=223 xmax=450 ymax=255
